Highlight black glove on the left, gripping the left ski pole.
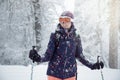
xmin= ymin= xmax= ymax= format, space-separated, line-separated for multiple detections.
xmin=29 ymin=49 xmax=41 ymax=63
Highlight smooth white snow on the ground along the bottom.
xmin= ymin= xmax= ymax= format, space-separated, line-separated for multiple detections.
xmin=0 ymin=65 xmax=120 ymax=80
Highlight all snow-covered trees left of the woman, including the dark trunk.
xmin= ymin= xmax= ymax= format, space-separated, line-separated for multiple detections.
xmin=0 ymin=0 xmax=64 ymax=65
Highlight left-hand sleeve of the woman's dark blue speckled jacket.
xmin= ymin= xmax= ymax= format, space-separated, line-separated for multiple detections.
xmin=41 ymin=33 xmax=55 ymax=62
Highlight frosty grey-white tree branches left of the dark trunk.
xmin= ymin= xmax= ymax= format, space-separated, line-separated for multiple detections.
xmin=0 ymin=0 xmax=34 ymax=64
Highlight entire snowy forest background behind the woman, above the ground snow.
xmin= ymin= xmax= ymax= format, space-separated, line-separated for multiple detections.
xmin=0 ymin=0 xmax=120 ymax=68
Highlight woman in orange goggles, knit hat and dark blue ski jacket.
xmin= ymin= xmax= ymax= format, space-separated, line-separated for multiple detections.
xmin=29 ymin=11 xmax=104 ymax=80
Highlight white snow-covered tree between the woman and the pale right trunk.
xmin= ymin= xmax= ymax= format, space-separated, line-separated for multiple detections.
xmin=75 ymin=0 xmax=109 ymax=66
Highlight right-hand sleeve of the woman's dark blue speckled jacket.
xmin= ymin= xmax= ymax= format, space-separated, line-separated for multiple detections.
xmin=75 ymin=36 xmax=93 ymax=69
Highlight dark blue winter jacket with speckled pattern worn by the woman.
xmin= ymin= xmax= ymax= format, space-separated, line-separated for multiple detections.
xmin=41 ymin=24 xmax=93 ymax=79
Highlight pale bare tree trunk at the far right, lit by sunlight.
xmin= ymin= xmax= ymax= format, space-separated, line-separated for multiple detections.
xmin=109 ymin=0 xmax=120 ymax=68
